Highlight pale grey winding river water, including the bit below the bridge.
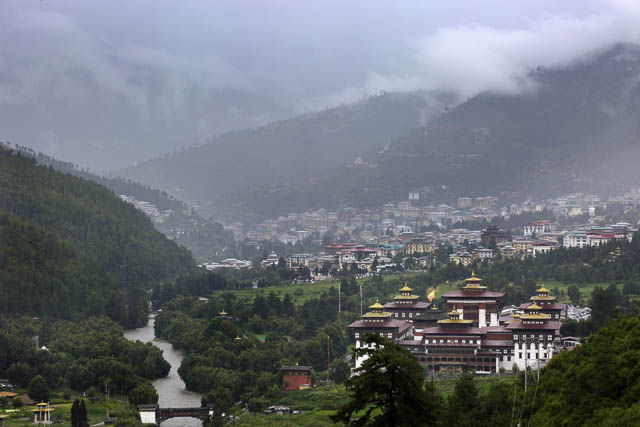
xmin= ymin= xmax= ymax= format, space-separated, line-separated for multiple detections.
xmin=124 ymin=318 xmax=202 ymax=427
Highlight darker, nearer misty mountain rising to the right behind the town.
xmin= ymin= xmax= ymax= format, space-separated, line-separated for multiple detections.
xmin=216 ymin=46 xmax=640 ymax=221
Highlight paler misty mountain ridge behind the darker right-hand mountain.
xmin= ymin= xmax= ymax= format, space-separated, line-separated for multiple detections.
xmin=118 ymin=91 xmax=455 ymax=214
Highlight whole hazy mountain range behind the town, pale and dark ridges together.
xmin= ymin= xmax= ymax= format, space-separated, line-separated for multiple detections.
xmin=120 ymin=45 xmax=640 ymax=221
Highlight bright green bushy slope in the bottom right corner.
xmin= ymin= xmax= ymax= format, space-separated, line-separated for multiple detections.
xmin=531 ymin=316 xmax=640 ymax=426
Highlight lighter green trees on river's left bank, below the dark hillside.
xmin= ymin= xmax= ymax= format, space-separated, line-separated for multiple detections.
xmin=0 ymin=317 xmax=170 ymax=402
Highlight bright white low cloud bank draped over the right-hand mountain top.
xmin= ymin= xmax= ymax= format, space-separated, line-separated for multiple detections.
xmin=300 ymin=1 xmax=640 ymax=109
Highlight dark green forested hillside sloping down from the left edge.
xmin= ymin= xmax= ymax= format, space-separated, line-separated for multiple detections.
xmin=0 ymin=147 xmax=193 ymax=326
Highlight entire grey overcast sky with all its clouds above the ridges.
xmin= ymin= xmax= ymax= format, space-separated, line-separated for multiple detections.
xmin=0 ymin=0 xmax=640 ymax=170
